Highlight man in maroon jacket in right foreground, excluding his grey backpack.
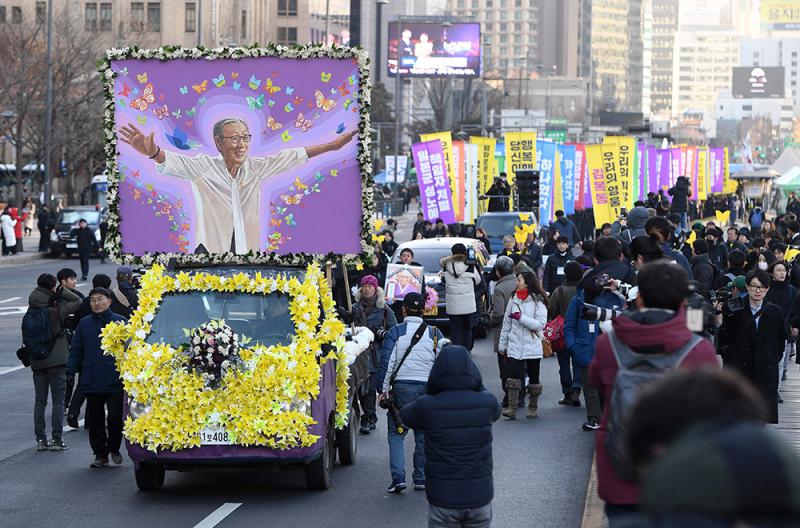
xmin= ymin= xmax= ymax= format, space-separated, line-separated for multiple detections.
xmin=589 ymin=260 xmax=719 ymax=526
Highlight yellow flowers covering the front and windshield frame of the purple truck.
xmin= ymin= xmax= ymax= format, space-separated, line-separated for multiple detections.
xmin=102 ymin=264 xmax=350 ymax=451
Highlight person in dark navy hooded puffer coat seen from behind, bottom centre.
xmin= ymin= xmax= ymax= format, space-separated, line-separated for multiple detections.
xmin=400 ymin=345 xmax=501 ymax=526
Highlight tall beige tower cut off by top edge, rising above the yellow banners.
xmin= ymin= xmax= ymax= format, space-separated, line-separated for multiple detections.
xmin=578 ymin=0 xmax=644 ymax=113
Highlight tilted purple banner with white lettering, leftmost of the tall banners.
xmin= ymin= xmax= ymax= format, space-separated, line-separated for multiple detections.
xmin=411 ymin=139 xmax=456 ymax=224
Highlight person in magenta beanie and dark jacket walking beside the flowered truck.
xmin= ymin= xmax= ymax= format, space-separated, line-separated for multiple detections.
xmin=339 ymin=275 xmax=397 ymax=434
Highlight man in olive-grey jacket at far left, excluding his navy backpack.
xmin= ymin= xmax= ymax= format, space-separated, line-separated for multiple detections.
xmin=28 ymin=273 xmax=81 ymax=451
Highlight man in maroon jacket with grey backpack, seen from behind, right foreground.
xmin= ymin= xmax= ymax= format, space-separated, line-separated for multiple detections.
xmin=589 ymin=261 xmax=719 ymax=526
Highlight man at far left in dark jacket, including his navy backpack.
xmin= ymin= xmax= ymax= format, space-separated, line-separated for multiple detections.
xmin=22 ymin=273 xmax=81 ymax=451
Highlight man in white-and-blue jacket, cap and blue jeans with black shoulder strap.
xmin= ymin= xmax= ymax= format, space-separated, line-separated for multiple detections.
xmin=376 ymin=292 xmax=450 ymax=493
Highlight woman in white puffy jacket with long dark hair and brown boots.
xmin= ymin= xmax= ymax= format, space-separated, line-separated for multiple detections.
xmin=497 ymin=272 xmax=548 ymax=420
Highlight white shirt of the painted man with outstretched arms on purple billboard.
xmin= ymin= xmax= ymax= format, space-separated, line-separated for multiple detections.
xmin=156 ymin=147 xmax=308 ymax=253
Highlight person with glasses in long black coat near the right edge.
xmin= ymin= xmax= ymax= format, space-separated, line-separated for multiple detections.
xmin=717 ymin=270 xmax=787 ymax=423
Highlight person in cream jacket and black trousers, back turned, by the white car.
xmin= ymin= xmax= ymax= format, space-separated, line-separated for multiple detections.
xmin=440 ymin=244 xmax=482 ymax=350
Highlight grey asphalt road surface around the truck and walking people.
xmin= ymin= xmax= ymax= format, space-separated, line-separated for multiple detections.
xmin=0 ymin=252 xmax=593 ymax=528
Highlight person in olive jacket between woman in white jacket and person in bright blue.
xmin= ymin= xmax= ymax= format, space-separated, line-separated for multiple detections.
xmin=547 ymin=261 xmax=583 ymax=407
